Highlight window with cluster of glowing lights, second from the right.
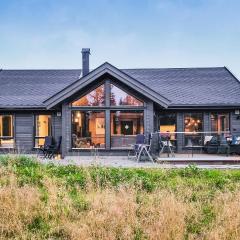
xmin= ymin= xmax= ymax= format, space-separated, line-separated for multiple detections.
xmin=184 ymin=113 xmax=203 ymax=146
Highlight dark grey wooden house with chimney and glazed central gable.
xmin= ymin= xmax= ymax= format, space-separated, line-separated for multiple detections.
xmin=0 ymin=49 xmax=240 ymax=156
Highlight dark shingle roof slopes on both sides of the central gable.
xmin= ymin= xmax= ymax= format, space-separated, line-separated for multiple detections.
xmin=0 ymin=67 xmax=240 ymax=108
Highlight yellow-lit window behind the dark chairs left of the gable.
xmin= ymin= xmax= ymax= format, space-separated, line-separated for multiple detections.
xmin=35 ymin=115 xmax=52 ymax=147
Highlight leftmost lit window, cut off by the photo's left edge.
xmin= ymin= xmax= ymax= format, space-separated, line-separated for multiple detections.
xmin=0 ymin=115 xmax=14 ymax=148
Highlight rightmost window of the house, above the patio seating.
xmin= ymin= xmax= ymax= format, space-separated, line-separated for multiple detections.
xmin=211 ymin=113 xmax=229 ymax=133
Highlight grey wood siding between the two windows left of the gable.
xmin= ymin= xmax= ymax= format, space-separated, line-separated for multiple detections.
xmin=15 ymin=113 xmax=34 ymax=153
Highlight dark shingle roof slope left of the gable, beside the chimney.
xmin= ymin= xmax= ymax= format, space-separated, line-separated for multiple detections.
xmin=0 ymin=69 xmax=81 ymax=108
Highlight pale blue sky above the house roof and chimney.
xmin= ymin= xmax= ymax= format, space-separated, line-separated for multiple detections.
xmin=0 ymin=0 xmax=240 ymax=78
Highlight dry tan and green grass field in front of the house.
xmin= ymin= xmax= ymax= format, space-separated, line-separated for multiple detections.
xmin=0 ymin=156 xmax=240 ymax=240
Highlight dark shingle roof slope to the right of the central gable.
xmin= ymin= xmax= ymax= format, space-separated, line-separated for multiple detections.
xmin=123 ymin=67 xmax=240 ymax=105
